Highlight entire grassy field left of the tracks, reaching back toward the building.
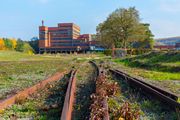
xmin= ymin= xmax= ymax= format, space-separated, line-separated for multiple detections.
xmin=0 ymin=51 xmax=103 ymax=100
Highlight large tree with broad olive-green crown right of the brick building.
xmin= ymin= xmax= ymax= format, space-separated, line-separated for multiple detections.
xmin=97 ymin=7 xmax=154 ymax=49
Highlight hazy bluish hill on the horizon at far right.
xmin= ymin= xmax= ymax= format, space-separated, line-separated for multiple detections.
xmin=155 ymin=36 xmax=180 ymax=45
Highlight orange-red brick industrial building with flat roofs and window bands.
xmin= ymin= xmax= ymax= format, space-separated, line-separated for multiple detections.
xmin=39 ymin=21 xmax=94 ymax=53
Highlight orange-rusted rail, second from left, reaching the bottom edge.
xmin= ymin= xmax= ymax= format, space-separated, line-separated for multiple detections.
xmin=61 ymin=70 xmax=77 ymax=120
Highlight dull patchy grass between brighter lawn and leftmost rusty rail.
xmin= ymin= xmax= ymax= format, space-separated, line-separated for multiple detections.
xmin=0 ymin=60 xmax=70 ymax=99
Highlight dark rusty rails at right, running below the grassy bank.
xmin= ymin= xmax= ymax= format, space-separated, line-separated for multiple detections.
xmin=110 ymin=69 xmax=180 ymax=109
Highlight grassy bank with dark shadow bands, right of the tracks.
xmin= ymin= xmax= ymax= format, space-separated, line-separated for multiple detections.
xmin=113 ymin=52 xmax=180 ymax=80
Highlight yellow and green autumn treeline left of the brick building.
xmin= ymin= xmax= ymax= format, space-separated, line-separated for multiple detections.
xmin=0 ymin=38 xmax=35 ymax=54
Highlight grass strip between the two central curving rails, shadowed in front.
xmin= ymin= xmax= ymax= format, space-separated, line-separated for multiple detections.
xmin=73 ymin=62 xmax=96 ymax=120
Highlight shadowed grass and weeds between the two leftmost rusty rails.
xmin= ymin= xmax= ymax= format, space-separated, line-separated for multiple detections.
xmin=0 ymin=74 xmax=70 ymax=120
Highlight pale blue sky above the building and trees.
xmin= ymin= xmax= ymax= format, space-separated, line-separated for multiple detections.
xmin=0 ymin=0 xmax=180 ymax=40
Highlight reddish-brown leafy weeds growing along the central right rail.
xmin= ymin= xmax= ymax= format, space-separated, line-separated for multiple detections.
xmin=90 ymin=63 xmax=129 ymax=120
